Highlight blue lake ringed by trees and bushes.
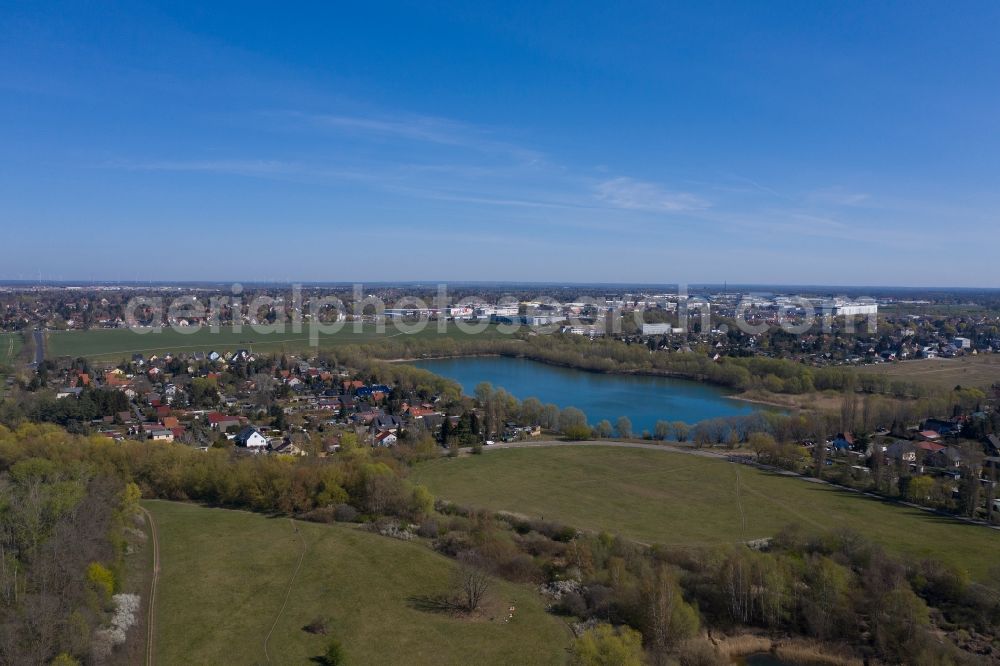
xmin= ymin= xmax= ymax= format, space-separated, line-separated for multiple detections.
xmin=412 ymin=356 xmax=761 ymax=434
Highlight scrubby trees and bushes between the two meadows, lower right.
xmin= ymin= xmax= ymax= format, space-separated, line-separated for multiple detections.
xmin=428 ymin=504 xmax=1000 ymax=666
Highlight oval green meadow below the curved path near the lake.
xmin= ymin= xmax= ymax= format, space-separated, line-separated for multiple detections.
xmin=413 ymin=446 xmax=1000 ymax=578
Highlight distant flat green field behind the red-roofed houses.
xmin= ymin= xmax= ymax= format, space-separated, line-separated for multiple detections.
xmin=47 ymin=322 xmax=510 ymax=362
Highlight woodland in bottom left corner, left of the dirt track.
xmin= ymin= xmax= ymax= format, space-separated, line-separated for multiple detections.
xmin=0 ymin=444 xmax=138 ymax=666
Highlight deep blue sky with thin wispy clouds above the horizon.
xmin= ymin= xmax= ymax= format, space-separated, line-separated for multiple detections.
xmin=0 ymin=1 xmax=1000 ymax=287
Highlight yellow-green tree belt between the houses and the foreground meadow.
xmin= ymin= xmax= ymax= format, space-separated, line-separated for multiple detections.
xmin=0 ymin=424 xmax=437 ymax=519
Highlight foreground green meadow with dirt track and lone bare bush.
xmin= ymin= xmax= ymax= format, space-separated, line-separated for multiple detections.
xmin=144 ymin=501 xmax=570 ymax=664
